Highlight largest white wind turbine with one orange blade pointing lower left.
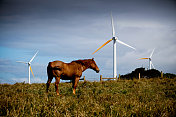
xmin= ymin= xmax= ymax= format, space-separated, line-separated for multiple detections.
xmin=92 ymin=14 xmax=136 ymax=78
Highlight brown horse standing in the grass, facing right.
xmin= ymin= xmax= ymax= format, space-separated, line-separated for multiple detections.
xmin=46 ymin=58 xmax=100 ymax=95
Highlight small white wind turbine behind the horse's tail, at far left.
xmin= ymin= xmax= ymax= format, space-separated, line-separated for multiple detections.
xmin=17 ymin=51 xmax=38 ymax=84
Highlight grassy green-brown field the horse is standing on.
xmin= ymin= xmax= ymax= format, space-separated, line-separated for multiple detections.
xmin=0 ymin=78 xmax=176 ymax=117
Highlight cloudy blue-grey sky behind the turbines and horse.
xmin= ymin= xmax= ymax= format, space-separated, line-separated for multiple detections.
xmin=0 ymin=0 xmax=176 ymax=84
